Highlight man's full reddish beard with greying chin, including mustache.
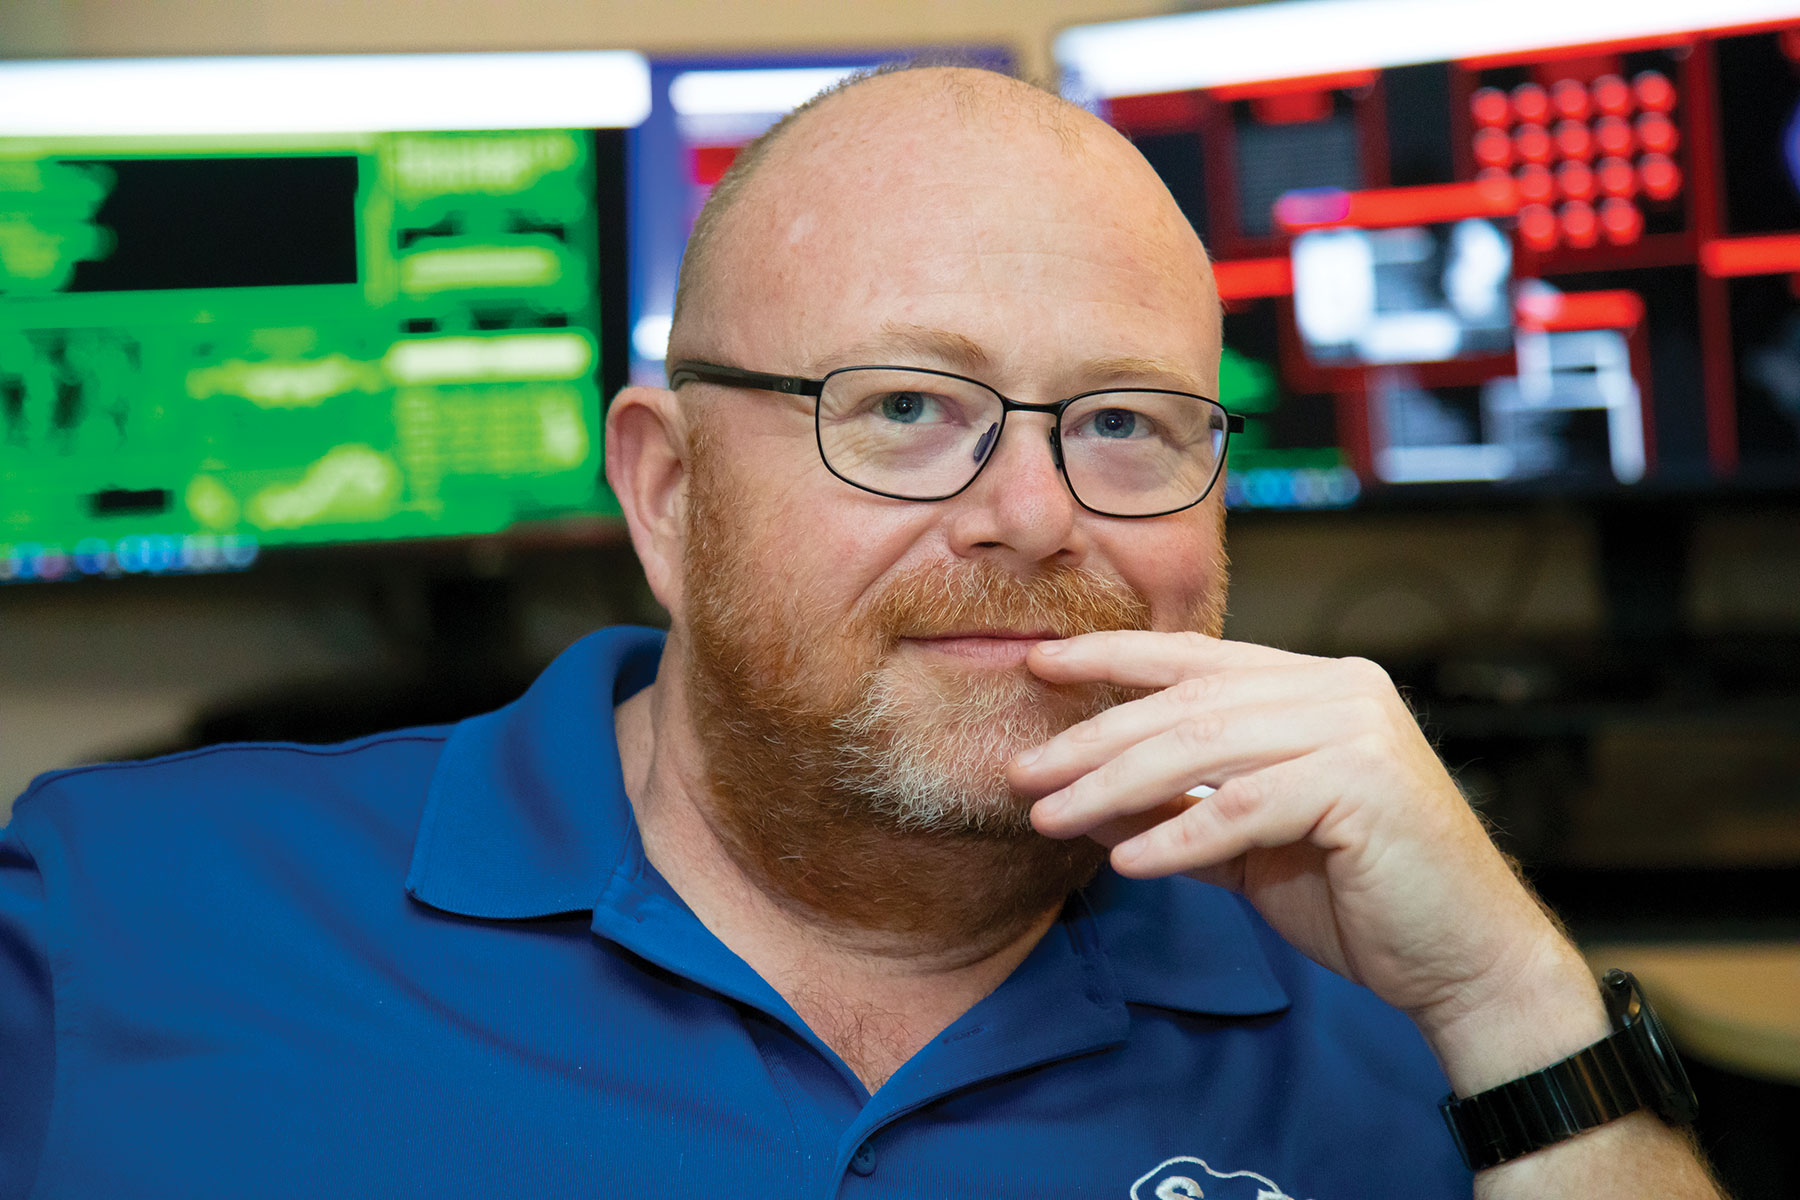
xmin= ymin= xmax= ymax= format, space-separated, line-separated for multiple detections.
xmin=684 ymin=435 xmax=1215 ymax=948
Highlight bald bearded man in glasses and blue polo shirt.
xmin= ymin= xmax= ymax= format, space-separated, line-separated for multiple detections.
xmin=0 ymin=68 xmax=1714 ymax=1200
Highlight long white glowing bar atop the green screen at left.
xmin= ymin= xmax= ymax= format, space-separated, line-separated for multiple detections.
xmin=0 ymin=50 xmax=650 ymax=137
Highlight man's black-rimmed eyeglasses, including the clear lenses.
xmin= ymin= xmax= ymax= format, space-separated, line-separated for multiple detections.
xmin=670 ymin=362 xmax=1244 ymax=516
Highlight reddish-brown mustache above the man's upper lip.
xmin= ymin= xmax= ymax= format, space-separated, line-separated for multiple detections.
xmin=860 ymin=561 xmax=1150 ymax=642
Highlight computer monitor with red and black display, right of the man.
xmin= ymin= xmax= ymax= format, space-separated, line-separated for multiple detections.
xmin=1057 ymin=0 xmax=1800 ymax=509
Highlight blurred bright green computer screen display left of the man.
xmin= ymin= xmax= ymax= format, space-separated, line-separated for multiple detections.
xmin=0 ymin=130 xmax=623 ymax=581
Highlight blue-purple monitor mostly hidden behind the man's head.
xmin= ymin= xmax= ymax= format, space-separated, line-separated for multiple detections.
xmin=630 ymin=45 xmax=1013 ymax=385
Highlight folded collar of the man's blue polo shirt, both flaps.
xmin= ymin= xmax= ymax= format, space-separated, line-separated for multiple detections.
xmin=407 ymin=626 xmax=1287 ymax=1016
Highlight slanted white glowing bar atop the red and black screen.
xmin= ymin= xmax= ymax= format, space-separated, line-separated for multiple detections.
xmin=1055 ymin=0 xmax=1800 ymax=99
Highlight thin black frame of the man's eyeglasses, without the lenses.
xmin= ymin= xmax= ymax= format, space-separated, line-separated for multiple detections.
xmin=670 ymin=360 xmax=1244 ymax=520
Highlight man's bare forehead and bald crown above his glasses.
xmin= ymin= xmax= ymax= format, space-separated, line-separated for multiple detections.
xmin=694 ymin=81 xmax=1219 ymax=394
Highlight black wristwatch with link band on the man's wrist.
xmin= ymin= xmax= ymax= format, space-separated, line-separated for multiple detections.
xmin=1440 ymin=970 xmax=1699 ymax=1171
